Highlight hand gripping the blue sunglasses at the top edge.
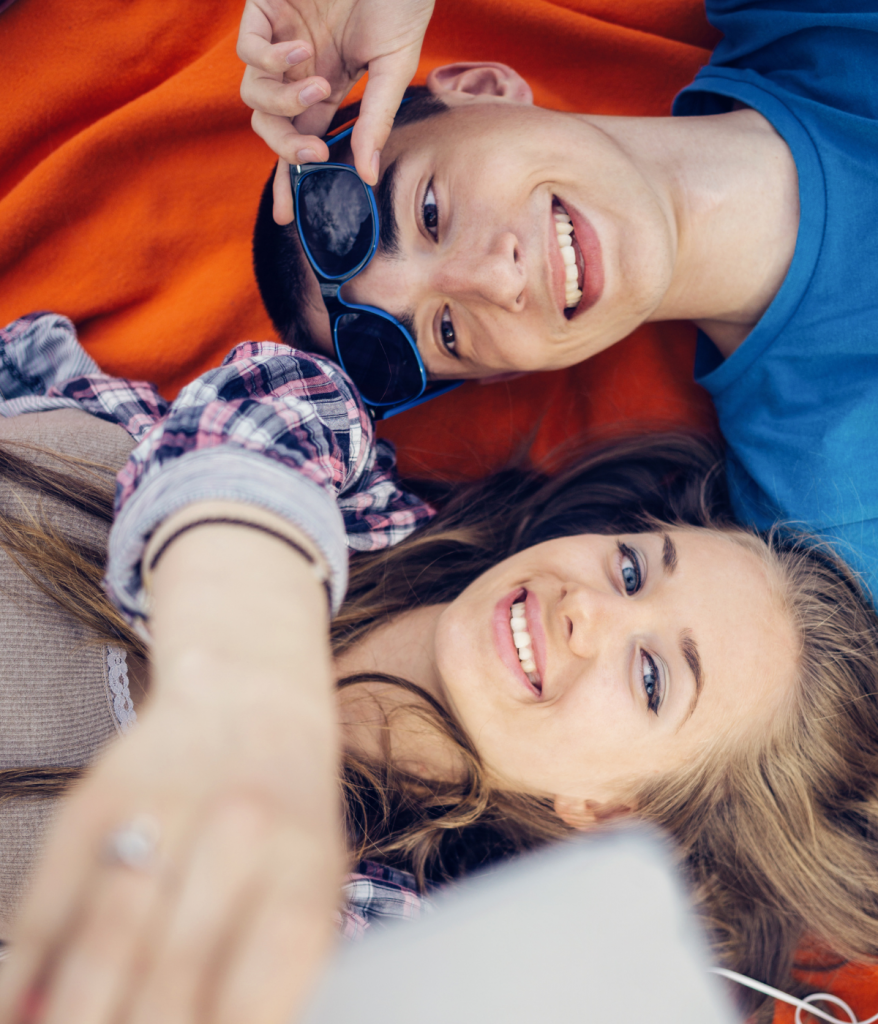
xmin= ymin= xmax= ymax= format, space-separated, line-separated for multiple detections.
xmin=238 ymin=0 xmax=433 ymax=224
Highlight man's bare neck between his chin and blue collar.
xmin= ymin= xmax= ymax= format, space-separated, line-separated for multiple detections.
xmin=595 ymin=109 xmax=799 ymax=357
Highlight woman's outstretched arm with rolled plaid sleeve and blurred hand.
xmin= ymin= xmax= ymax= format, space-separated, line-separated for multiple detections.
xmin=0 ymin=314 xmax=432 ymax=1024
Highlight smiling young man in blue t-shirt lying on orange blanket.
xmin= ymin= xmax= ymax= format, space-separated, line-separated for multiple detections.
xmin=244 ymin=0 xmax=878 ymax=598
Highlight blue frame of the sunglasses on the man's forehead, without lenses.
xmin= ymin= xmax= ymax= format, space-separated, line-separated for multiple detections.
xmin=290 ymin=120 xmax=462 ymax=420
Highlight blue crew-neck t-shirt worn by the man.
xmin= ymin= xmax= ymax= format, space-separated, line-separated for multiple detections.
xmin=673 ymin=0 xmax=878 ymax=598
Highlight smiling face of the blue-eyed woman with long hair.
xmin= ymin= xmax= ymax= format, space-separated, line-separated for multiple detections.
xmin=433 ymin=529 xmax=798 ymax=818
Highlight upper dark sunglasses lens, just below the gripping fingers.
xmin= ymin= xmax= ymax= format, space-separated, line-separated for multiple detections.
xmin=297 ymin=167 xmax=374 ymax=278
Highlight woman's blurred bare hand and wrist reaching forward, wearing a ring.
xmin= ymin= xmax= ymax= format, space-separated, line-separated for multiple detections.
xmin=0 ymin=525 xmax=343 ymax=1024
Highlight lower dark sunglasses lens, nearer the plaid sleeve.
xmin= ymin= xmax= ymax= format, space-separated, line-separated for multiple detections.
xmin=335 ymin=312 xmax=423 ymax=406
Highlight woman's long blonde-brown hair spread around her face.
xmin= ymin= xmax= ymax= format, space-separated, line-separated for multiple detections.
xmin=0 ymin=435 xmax=878 ymax=1012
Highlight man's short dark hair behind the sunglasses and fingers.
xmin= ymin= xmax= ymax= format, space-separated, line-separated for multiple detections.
xmin=253 ymin=86 xmax=448 ymax=351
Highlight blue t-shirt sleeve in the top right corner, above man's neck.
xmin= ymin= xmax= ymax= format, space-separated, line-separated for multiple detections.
xmin=692 ymin=0 xmax=878 ymax=118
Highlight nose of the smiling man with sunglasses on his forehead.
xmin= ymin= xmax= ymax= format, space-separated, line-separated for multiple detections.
xmin=432 ymin=231 xmax=527 ymax=312
